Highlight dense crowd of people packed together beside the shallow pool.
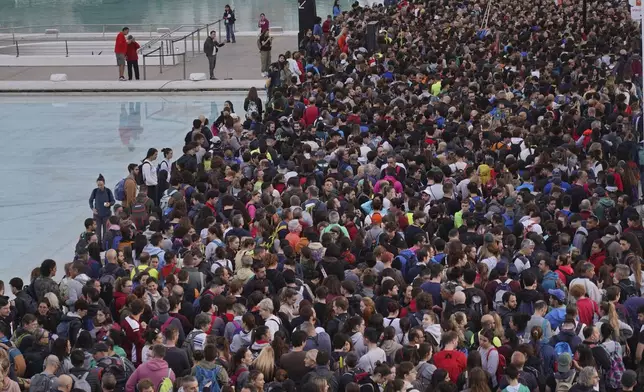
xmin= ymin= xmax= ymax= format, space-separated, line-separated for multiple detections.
xmin=10 ymin=0 xmax=644 ymax=392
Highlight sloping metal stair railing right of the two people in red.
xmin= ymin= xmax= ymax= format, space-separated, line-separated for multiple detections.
xmin=140 ymin=19 xmax=223 ymax=80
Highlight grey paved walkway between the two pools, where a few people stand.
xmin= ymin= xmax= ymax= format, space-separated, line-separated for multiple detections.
xmin=0 ymin=36 xmax=297 ymax=81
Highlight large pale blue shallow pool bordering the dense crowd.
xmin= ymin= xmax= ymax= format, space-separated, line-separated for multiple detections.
xmin=0 ymin=92 xmax=253 ymax=281
